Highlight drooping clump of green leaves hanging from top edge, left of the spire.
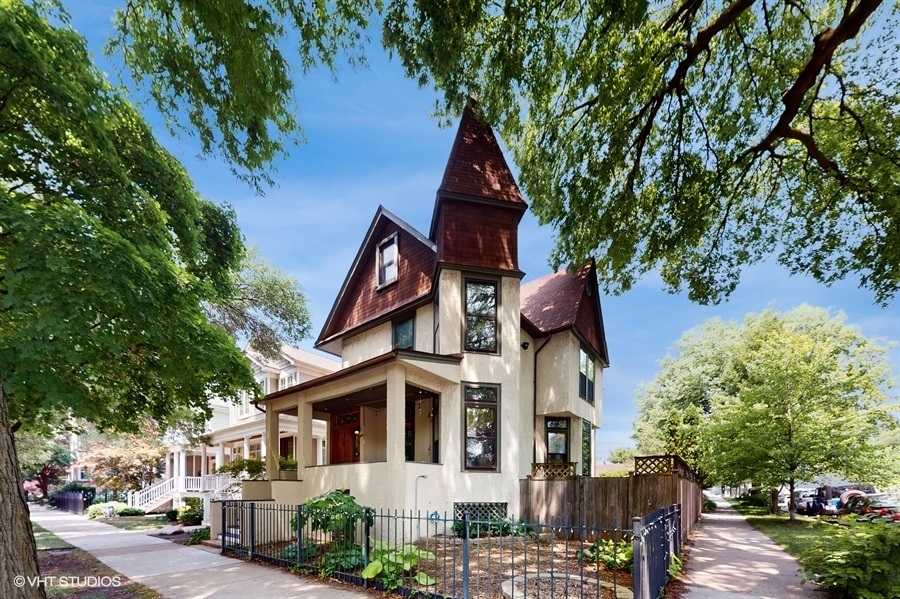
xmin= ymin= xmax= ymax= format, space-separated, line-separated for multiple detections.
xmin=108 ymin=0 xmax=380 ymax=185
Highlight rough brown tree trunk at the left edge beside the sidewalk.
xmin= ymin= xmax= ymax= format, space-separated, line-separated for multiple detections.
xmin=0 ymin=379 xmax=47 ymax=599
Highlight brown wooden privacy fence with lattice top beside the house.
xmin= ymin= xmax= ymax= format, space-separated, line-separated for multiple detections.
xmin=519 ymin=455 xmax=702 ymax=540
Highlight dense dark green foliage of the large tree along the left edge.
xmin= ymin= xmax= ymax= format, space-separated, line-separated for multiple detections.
xmin=0 ymin=2 xmax=255 ymax=430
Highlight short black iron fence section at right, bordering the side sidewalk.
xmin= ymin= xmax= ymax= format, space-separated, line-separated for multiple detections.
xmin=633 ymin=504 xmax=681 ymax=599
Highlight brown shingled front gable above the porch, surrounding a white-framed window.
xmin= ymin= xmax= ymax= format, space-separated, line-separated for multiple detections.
xmin=315 ymin=206 xmax=436 ymax=354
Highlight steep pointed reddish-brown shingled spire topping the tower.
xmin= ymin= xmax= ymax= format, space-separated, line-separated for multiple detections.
xmin=438 ymin=100 xmax=525 ymax=207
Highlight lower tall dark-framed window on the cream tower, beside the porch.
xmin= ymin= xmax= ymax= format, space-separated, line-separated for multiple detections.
xmin=464 ymin=385 xmax=500 ymax=470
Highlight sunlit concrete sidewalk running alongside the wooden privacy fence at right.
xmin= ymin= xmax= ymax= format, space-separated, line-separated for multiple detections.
xmin=684 ymin=496 xmax=824 ymax=599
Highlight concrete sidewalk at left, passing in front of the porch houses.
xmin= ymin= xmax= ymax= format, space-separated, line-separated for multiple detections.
xmin=31 ymin=504 xmax=372 ymax=599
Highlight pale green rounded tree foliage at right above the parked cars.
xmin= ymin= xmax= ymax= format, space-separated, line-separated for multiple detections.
xmin=635 ymin=306 xmax=898 ymax=496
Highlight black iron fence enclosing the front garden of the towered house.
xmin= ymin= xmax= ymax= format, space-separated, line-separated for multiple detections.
xmin=221 ymin=501 xmax=681 ymax=599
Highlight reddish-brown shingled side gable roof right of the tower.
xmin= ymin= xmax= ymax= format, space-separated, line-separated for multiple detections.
xmin=520 ymin=260 xmax=609 ymax=365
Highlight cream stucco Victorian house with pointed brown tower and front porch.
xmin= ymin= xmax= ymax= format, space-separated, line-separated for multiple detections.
xmin=250 ymin=101 xmax=608 ymax=514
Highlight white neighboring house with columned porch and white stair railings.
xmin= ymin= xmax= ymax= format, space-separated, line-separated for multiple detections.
xmin=129 ymin=345 xmax=340 ymax=511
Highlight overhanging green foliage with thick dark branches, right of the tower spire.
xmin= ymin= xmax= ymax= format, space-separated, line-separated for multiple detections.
xmin=384 ymin=0 xmax=900 ymax=303
